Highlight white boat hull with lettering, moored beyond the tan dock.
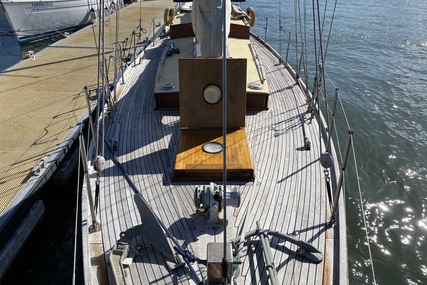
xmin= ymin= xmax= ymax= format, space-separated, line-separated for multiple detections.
xmin=0 ymin=0 xmax=123 ymax=43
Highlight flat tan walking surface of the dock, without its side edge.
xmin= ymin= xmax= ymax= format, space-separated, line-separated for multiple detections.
xmin=0 ymin=0 xmax=173 ymax=213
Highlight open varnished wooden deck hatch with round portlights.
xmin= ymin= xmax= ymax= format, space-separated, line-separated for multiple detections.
xmin=172 ymin=58 xmax=254 ymax=181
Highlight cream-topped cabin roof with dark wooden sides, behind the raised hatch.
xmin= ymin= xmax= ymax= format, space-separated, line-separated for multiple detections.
xmin=154 ymin=7 xmax=270 ymax=110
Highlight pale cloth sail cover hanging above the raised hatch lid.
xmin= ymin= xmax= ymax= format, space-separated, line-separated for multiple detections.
xmin=191 ymin=0 xmax=231 ymax=58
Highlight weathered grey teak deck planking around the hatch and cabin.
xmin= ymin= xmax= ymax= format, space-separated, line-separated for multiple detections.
xmin=83 ymin=36 xmax=339 ymax=284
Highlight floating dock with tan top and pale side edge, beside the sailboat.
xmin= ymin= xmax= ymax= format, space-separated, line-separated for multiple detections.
xmin=0 ymin=0 xmax=173 ymax=277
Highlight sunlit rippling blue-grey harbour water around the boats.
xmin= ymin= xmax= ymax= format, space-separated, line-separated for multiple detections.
xmin=0 ymin=0 xmax=427 ymax=285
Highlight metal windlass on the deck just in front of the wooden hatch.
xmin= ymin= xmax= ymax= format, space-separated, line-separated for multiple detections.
xmin=194 ymin=182 xmax=240 ymax=226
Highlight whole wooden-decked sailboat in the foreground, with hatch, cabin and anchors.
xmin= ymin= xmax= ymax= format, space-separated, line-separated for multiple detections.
xmin=81 ymin=0 xmax=351 ymax=284
